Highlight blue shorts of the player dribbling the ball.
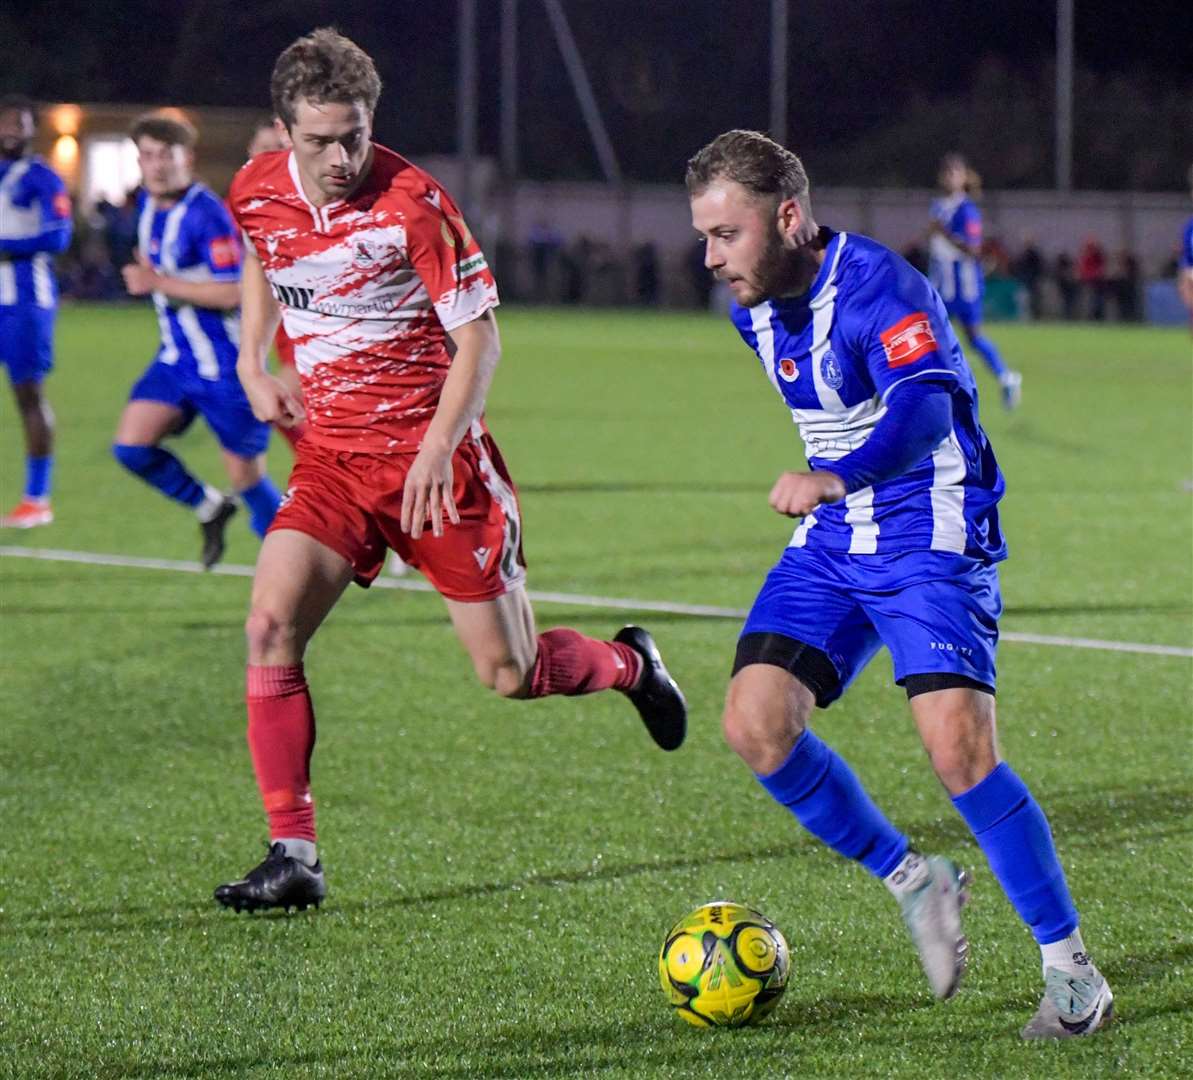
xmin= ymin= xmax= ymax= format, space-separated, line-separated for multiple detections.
xmin=742 ymin=548 xmax=1002 ymax=705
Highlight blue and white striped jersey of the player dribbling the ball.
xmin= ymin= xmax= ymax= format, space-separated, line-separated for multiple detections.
xmin=730 ymin=229 xmax=1007 ymax=562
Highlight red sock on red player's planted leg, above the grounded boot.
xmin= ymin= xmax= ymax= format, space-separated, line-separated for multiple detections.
xmin=245 ymin=664 xmax=315 ymax=843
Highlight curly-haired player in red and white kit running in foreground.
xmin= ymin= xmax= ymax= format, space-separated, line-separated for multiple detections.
xmin=216 ymin=29 xmax=687 ymax=911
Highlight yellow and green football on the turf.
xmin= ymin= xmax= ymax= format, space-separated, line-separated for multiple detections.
xmin=659 ymin=900 xmax=791 ymax=1027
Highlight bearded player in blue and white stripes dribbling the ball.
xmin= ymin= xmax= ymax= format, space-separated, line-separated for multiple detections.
xmin=686 ymin=131 xmax=1112 ymax=1038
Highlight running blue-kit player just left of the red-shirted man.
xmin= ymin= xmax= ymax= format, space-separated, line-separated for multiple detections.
xmin=112 ymin=113 xmax=280 ymax=568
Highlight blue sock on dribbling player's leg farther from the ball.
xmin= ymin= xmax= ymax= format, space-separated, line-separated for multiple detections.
xmin=953 ymin=761 xmax=1077 ymax=945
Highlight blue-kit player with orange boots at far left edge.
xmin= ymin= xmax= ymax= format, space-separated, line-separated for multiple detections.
xmin=0 ymin=97 xmax=70 ymax=529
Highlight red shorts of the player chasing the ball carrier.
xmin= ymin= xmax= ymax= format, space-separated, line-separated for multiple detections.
xmin=276 ymin=432 xmax=526 ymax=603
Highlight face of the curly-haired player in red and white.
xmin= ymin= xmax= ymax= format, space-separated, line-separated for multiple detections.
xmin=290 ymin=98 xmax=372 ymax=204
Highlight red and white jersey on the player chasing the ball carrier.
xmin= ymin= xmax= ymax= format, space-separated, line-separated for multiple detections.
xmin=228 ymin=143 xmax=497 ymax=453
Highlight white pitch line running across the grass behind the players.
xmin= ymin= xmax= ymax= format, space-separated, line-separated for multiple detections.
xmin=0 ymin=545 xmax=1193 ymax=659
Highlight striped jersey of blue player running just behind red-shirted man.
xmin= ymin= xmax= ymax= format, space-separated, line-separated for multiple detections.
xmin=137 ymin=183 xmax=241 ymax=379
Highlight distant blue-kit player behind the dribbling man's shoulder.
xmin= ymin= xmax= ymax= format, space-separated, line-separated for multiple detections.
xmin=928 ymin=154 xmax=1024 ymax=409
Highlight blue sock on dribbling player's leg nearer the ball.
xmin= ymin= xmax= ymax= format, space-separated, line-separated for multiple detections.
xmin=758 ymin=730 xmax=909 ymax=877
